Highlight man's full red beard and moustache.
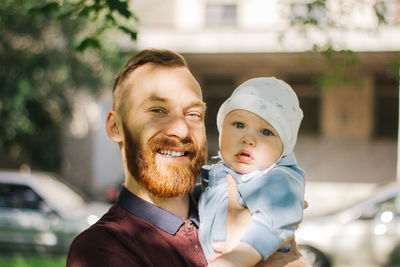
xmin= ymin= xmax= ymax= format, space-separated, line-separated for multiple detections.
xmin=123 ymin=124 xmax=207 ymax=198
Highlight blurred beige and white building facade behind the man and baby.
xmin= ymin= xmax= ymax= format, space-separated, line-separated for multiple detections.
xmin=63 ymin=0 xmax=400 ymax=199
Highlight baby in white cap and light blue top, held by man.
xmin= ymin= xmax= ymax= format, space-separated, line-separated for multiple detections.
xmin=199 ymin=77 xmax=305 ymax=266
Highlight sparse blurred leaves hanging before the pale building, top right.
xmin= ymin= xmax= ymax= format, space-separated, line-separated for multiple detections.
xmin=288 ymin=0 xmax=399 ymax=89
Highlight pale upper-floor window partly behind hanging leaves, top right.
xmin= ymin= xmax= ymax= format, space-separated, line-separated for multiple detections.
xmin=290 ymin=0 xmax=328 ymax=25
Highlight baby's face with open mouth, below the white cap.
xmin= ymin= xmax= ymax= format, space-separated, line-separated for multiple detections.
xmin=220 ymin=109 xmax=283 ymax=174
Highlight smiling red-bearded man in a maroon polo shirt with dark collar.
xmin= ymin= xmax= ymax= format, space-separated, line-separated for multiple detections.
xmin=67 ymin=50 xmax=310 ymax=267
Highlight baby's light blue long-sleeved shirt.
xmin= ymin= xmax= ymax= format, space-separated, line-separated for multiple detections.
xmin=199 ymin=153 xmax=305 ymax=260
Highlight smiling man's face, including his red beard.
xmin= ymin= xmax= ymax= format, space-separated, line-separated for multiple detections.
xmin=119 ymin=63 xmax=207 ymax=198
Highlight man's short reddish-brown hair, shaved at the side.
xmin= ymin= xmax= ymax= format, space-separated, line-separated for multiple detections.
xmin=113 ymin=49 xmax=188 ymax=117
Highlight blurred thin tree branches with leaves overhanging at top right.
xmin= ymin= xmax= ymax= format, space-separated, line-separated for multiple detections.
xmin=280 ymin=0 xmax=400 ymax=88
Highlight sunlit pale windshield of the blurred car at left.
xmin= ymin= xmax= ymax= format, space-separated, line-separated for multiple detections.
xmin=37 ymin=175 xmax=85 ymax=211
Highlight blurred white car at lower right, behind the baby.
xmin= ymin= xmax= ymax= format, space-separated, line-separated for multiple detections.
xmin=295 ymin=183 xmax=400 ymax=267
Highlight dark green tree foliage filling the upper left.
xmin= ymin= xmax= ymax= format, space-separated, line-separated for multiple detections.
xmin=0 ymin=0 xmax=136 ymax=172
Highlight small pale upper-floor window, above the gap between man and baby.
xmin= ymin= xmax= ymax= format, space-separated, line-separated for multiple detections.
xmin=206 ymin=3 xmax=237 ymax=27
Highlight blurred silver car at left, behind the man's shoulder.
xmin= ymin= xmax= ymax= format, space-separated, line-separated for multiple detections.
xmin=0 ymin=170 xmax=110 ymax=253
